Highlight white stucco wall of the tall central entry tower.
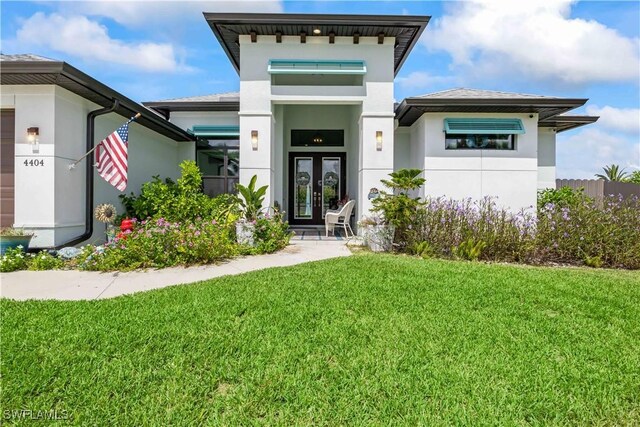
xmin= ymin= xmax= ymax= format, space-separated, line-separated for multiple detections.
xmin=239 ymin=36 xmax=395 ymax=213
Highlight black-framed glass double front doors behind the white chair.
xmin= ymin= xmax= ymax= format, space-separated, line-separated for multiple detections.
xmin=288 ymin=153 xmax=347 ymax=225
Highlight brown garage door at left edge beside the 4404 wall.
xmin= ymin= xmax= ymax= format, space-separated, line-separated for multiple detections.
xmin=0 ymin=110 xmax=16 ymax=227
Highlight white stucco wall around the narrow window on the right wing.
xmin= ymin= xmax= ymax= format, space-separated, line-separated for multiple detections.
xmin=412 ymin=113 xmax=538 ymax=211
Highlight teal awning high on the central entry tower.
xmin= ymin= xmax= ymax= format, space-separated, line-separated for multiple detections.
xmin=268 ymin=59 xmax=367 ymax=75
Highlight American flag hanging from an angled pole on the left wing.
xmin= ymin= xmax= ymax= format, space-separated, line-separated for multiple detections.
xmin=96 ymin=120 xmax=131 ymax=191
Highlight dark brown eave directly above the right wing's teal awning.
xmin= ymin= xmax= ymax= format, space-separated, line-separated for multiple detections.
xmin=396 ymin=98 xmax=588 ymax=126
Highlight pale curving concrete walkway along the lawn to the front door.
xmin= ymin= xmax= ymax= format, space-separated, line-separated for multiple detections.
xmin=0 ymin=240 xmax=351 ymax=300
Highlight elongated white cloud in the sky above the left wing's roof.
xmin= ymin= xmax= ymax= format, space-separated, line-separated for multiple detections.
xmin=10 ymin=12 xmax=187 ymax=72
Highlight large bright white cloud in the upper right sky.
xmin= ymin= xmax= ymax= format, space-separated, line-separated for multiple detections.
xmin=422 ymin=0 xmax=640 ymax=84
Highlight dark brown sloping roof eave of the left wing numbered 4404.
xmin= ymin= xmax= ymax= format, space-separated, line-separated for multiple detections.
xmin=0 ymin=61 xmax=194 ymax=141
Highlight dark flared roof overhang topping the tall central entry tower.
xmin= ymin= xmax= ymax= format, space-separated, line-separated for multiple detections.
xmin=204 ymin=13 xmax=431 ymax=74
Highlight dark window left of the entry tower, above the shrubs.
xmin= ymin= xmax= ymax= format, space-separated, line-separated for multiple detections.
xmin=196 ymin=138 xmax=240 ymax=197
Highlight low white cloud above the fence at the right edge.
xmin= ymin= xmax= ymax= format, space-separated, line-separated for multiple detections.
xmin=556 ymin=127 xmax=640 ymax=179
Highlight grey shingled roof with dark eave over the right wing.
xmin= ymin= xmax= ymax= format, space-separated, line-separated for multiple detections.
xmin=396 ymin=88 xmax=597 ymax=126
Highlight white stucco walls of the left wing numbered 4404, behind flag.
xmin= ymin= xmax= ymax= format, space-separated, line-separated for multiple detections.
xmin=2 ymin=85 xmax=193 ymax=247
